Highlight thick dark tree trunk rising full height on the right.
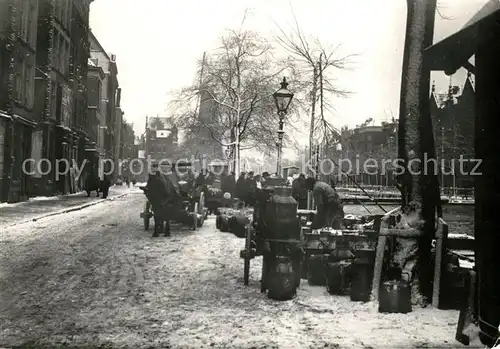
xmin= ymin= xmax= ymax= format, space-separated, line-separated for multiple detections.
xmin=394 ymin=0 xmax=436 ymax=302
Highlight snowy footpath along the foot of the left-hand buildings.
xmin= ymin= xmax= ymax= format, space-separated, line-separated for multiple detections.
xmin=0 ymin=185 xmax=137 ymax=227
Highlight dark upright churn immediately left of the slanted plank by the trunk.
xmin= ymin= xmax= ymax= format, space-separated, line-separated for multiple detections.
xmin=350 ymin=250 xmax=376 ymax=302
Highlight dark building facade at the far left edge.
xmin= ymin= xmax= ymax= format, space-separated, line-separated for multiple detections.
xmin=0 ymin=0 xmax=39 ymax=202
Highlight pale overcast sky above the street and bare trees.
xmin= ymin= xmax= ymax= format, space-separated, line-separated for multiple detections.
xmin=90 ymin=0 xmax=486 ymax=148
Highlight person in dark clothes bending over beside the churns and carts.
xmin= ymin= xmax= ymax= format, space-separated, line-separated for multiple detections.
xmin=306 ymin=177 xmax=344 ymax=229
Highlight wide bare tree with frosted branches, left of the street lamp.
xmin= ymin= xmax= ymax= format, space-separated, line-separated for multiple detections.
xmin=172 ymin=12 xmax=293 ymax=174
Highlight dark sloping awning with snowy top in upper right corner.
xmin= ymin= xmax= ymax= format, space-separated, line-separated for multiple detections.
xmin=424 ymin=0 xmax=500 ymax=75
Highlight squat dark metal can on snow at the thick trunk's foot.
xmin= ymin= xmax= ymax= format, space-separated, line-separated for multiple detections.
xmin=378 ymin=274 xmax=412 ymax=314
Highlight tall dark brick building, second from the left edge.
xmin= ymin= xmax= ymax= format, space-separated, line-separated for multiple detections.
xmin=32 ymin=0 xmax=92 ymax=195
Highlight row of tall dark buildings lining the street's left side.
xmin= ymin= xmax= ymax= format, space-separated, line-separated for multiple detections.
xmin=0 ymin=0 xmax=135 ymax=202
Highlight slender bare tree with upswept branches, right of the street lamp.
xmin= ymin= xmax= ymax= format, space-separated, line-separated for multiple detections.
xmin=276 ymin=9 xmax=356 ymax=170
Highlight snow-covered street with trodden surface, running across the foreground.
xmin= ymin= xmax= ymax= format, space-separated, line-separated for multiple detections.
xmin=0 ymin=191 xmax=466 ymax=348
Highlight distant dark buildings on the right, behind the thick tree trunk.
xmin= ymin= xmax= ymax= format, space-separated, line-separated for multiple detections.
xmin=328 ymin=74 xmax=475 ymax=188
